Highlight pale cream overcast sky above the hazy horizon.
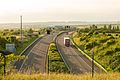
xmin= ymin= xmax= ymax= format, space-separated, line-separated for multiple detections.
xmin=0 ymin=0 xmax=120 ymax=23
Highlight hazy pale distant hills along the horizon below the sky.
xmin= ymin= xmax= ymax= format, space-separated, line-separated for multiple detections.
xmin=0 ymin=21 xmax=120 ymax=29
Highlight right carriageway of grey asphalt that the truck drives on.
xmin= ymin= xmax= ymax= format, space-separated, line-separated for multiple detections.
xmin=56 ymin=33 xmax=103 ymax=74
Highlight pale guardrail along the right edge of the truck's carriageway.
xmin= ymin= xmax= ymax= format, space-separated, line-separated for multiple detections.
xmin=70 ymin=36 xmax=107 ymax=73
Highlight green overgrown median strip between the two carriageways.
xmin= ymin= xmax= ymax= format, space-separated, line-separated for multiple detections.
xmin=48 ymin=43 xmax=68 ymax=73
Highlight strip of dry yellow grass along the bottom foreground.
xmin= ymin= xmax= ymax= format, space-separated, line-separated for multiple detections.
xmin=0 ymin=73 xmax=120 ymax=80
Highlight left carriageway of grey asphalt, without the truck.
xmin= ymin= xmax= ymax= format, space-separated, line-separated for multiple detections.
xmin=14 ymin=34 xmax=56 ymax=73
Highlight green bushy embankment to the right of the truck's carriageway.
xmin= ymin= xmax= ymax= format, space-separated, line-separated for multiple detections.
xmin=73 ymin=32 xmax=120 ymax=72
